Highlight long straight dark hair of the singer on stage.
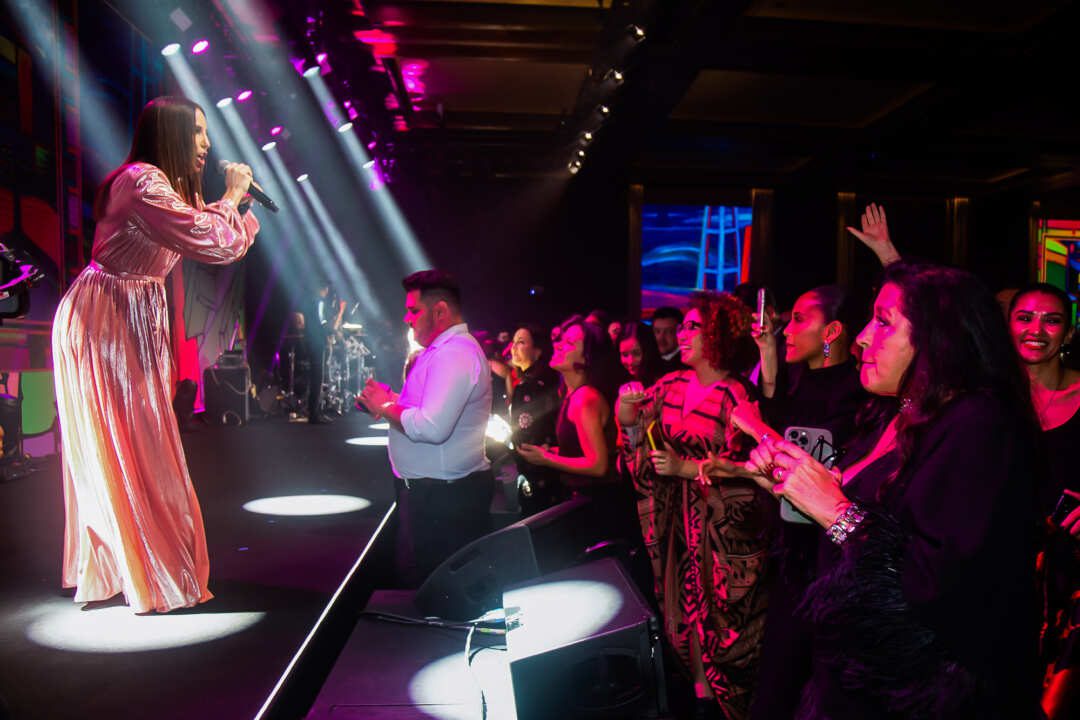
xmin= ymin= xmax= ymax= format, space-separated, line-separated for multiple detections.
xmin=94 ymin=95 xmax=206 ymax=220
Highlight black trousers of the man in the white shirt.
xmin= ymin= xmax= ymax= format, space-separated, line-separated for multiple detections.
xmin=394 ymin=470 xmax=495 ymax=587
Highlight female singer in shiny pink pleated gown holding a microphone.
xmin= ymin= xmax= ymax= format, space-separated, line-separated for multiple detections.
xmin=53 ymin=97 xmax=259 ymax=612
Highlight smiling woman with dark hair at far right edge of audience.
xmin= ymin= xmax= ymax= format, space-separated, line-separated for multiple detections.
xmin=1009 ymin=283 xmax=1080 ymax=720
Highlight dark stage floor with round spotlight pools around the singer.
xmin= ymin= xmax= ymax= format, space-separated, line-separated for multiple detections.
xmin=0 ymin=412 xmax=393 ymax=720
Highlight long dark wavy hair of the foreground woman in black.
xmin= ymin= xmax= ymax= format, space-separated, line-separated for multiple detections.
xmin=882 ymin=261 xmax=1038 ymax=492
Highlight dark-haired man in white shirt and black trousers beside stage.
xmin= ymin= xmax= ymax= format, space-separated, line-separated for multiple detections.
xmin=359 ymin=270 xmax=494 ymax=586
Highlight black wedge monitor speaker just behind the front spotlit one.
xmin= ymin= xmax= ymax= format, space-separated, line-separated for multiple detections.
xmin=416 ymin=498 xmax=610 ymax=621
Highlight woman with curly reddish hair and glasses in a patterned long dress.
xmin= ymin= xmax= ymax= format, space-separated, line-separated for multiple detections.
xmin=617 ymin=293 xmax=775 ymax=718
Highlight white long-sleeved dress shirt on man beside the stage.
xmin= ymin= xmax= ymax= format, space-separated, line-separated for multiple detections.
xmin=390 ymin=323 xmax=491 ymax=480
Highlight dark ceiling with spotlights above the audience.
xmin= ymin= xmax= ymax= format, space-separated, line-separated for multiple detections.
xmin=118 ymin=0 xmax=1080 ymax=195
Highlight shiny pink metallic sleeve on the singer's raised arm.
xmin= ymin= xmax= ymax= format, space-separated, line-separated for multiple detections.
xmin=123 ymin=164 xmax=259 ymax=264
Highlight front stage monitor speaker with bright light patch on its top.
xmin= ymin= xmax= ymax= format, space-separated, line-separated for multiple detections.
xmin=502 ymin=558 xmax=667 ymax=720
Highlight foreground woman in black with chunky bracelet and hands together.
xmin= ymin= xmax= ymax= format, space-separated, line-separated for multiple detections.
xmin=747 ymin=262 xmax=1039 ymax=720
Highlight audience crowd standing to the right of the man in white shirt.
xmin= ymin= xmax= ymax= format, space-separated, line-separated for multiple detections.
xmin=468 ymin=205 xmax=1080 ymax=719
